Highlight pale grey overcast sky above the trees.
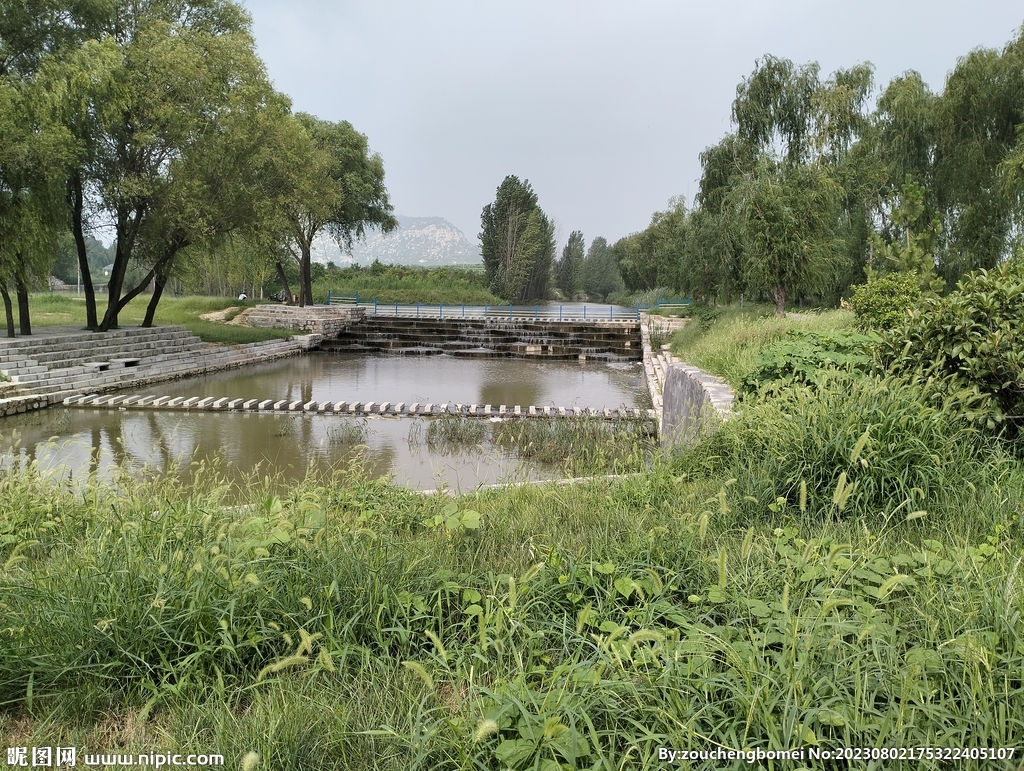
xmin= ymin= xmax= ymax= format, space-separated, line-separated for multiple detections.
xmin=235 ymin=0 xmax=1024 ymax=249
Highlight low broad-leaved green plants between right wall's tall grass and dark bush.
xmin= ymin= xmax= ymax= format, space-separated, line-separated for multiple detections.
xmin=740 ymin=330 xmax=879 ymax=394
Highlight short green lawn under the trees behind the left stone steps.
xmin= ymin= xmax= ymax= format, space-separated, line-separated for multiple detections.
xmin=20 ymin=293 xmax=294 ymax=345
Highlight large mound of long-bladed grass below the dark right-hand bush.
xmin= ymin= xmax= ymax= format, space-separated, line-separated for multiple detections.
xmin=686 ymin=370 xmax=1006 ymax=517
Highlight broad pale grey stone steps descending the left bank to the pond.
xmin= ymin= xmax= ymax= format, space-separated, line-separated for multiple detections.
xmin=0 ymin=327 xmax=303 ymax=401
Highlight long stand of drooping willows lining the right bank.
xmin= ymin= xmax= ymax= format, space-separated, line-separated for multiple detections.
xmin=611 ymin=24 xmax=1024 ymax=310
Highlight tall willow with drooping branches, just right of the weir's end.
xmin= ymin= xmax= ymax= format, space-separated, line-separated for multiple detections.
xmin=722 ymin=56 xmax=871 ymax=315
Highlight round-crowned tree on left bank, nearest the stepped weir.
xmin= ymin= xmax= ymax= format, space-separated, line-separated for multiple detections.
xmin=281 ymin=113 xmax=398 ymax=305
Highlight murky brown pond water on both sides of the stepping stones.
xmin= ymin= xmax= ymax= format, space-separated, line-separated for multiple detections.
xmin=0 ymin=353 xmax=649 ymax=490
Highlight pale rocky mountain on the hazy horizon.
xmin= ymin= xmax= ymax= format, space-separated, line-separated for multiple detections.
xmin=312 ymin=216 xmax=482 ymax=266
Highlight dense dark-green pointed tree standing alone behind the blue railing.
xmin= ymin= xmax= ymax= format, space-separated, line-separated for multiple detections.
xmin=479 ymin=175 xmax=555 ymax=302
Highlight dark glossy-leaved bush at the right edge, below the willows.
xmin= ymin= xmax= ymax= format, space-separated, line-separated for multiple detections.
xmin=880 ymin=260 xmax=1024 ymax=436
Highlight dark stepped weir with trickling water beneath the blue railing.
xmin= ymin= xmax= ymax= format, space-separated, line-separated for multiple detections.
xmin=321 ymin=316 xmax=642 ymax=361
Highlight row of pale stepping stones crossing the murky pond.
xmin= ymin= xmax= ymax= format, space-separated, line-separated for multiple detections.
xmin=63 ymin=394 xmax=657 ymax=420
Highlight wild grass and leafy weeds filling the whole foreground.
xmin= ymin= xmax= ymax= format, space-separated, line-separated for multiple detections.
xmin=0 ymin=450 xmax=1024 ymax=769
